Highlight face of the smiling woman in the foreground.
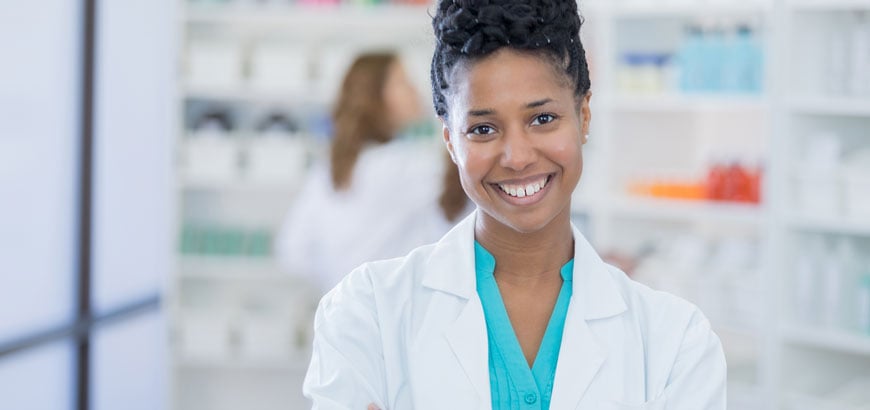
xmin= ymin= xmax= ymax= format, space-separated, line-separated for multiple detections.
xmin=444 ymin=49 xmax=590 ymax=233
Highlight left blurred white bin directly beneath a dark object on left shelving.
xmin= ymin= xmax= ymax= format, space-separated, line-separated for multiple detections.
xmin=182 ymin=133 xmax=239 ymax=184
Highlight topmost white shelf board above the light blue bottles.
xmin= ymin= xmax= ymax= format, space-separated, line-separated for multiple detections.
xmin=613 ymin=0 xmax=771 ymax=18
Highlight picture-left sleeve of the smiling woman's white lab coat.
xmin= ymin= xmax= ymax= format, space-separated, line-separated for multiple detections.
xmin=303 ymin=266 xmax=388 ymax=410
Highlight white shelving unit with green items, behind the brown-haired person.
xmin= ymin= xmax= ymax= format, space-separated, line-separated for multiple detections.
xmin=167 ymin=0 xmax=433 ymax=410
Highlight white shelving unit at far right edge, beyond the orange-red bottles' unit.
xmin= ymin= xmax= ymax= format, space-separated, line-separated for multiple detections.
xmin=774 ymin=0 xmax=870 ymax=410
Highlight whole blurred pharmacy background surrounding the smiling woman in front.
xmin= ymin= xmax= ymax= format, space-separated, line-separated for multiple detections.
xmin=0 ymin=0 xmax=870 ymax=410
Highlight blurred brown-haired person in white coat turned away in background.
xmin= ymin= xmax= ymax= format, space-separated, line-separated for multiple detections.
xmin=276 ymin=53 xmax=467 ymax=292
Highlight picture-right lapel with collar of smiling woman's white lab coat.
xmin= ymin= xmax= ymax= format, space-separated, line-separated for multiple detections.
xmin=550 ymin=228 xmax=627 ymax=409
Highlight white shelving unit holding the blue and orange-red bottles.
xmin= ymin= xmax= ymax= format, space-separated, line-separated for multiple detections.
xmin=574 ymin=0 xmax=778 ymax=409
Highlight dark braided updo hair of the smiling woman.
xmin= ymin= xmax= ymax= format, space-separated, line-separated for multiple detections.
xmin=430 ymin=0 xmax=591 ymax=118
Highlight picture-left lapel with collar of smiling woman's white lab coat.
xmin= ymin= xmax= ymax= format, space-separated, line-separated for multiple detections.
xmin=423 ymin=213 xmax=490 ymax=403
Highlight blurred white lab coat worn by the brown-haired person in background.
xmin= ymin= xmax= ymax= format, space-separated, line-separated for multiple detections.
xmin=275 ymin=141 xmax=460 ymax=293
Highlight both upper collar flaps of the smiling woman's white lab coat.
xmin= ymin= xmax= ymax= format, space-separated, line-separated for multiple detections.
xmin=423 ymin=211 xmax=627 ymax=320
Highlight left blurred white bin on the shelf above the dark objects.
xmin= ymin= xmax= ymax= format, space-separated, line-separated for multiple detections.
xmin=187 ymin=42 xmax=243 ymax=89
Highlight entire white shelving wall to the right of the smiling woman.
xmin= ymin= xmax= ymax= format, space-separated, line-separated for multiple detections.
xmin=575 ymin=0 xmax=870 ymax=409
